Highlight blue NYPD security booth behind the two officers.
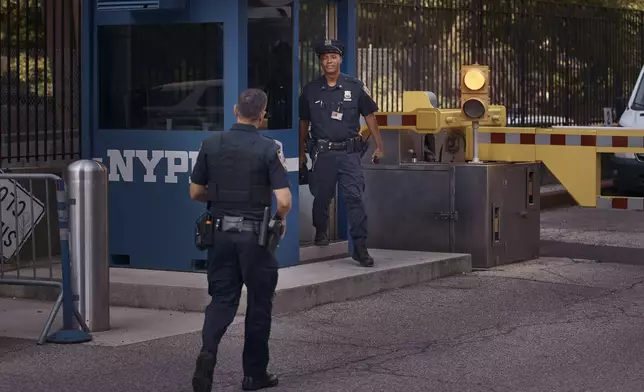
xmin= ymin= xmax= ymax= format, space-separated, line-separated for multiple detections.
xmin=82 ymin=0 xmax=356 ymax=271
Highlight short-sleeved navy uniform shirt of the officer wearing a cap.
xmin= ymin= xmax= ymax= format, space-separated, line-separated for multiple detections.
xmin=299 ymin=74 xmax=378 ymax=142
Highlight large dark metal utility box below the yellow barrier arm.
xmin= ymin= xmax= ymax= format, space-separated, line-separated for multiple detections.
xmin=364 ymin=162 xmax=541 ymax=268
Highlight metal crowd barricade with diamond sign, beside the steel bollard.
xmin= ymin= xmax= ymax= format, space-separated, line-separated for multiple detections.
xmin=0 ymin=172 xmax=91 ymax=344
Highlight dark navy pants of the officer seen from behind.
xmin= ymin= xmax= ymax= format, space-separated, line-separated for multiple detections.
xmin=202 ymin=232 xmax=278 ymax=377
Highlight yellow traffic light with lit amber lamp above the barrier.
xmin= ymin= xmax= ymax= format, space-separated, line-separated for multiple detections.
xmin=461 ymin=64 xmax=490 ymax=121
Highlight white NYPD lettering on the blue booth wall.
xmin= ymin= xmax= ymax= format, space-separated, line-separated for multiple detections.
xmin=94 ymin=150 xmax=299 ymax=184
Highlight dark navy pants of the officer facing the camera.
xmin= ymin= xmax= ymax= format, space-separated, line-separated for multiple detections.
xmin=309 ymin=151 xmax=367 ymax=245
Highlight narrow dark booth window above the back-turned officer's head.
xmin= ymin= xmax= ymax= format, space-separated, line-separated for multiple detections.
xmin=248 ymin=0 xmax=293 ymax=129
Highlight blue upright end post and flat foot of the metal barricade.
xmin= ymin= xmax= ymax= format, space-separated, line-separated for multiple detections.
xmin=47 ymin=178 xmax=92 ymax=343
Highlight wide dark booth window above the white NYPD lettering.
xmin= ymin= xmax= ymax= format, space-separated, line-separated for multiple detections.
xmin=98 ymin=23 xmax=224 ymax=131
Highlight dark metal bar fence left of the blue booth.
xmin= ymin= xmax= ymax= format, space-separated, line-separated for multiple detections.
xmin=0 ymin=0 xmax=80 ymax=167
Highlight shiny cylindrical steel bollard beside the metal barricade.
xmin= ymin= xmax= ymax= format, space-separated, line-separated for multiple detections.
xmin=67 ymin=160 xmax=110 ymax=332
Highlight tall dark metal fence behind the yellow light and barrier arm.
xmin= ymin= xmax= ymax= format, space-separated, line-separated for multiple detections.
xmin=358 ymin=0 xmax=644 ymax=125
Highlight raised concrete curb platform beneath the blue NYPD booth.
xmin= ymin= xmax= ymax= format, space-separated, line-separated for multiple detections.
xmin=0 ymin=249 xmax=472 ymax=315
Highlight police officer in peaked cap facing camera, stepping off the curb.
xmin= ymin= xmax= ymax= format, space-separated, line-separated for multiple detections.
xmin=299 ymin=40 xmax=383 ymax=267
